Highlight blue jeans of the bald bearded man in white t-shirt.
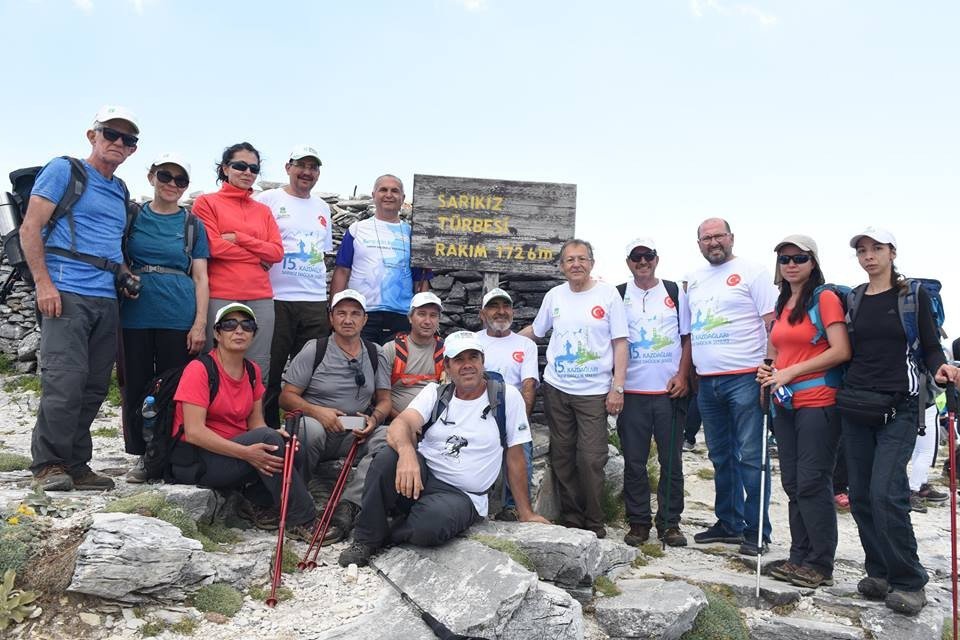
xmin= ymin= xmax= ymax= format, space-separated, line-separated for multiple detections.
xmin=697 ymin=373 xmax=771 ymax=543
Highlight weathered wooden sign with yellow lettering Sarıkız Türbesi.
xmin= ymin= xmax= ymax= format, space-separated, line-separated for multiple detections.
xmin=410 ymin=175 xmax=577 ymax=275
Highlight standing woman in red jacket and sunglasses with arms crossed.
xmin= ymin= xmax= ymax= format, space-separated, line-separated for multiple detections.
xmin=193 ymin=142 xmax=283 ymax=378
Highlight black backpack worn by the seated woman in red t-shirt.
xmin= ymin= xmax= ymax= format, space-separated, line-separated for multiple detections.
xmin=140 ymin=353 xmax=257 ymax=479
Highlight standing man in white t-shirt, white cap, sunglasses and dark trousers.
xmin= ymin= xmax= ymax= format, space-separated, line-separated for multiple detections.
xmin=617 ymin=238 xmax=690 ymax=547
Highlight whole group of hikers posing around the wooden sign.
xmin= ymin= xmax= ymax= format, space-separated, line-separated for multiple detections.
xmin=20 ymin=106 xmax=960 ymax=615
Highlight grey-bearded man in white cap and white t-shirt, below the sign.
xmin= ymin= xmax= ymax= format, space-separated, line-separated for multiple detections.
xmin=477 ymin=287 xmax=540 ymax=521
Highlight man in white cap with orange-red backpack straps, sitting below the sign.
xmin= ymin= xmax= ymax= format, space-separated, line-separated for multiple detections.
xmin=383 ymin=291 xmax=443 ymax=420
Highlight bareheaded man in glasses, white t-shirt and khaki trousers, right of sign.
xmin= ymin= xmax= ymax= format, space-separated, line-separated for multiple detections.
xmin=520 ymin=239 xmax=627 ymax=538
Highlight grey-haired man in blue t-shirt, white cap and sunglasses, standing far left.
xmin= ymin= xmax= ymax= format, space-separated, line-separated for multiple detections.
xmin=20 ymin=106 xmax=140 ymax=491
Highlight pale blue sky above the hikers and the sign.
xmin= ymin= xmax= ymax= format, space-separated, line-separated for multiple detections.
xmin=0 ymin=0 xmax=960 ymax=335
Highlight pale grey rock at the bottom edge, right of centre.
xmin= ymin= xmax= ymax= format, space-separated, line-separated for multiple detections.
xmin=596 ymin=580 xmax=707 ymax=640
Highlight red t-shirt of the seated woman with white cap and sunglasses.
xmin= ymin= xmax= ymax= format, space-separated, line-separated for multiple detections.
xmin=173 ymin=349 xmax=264 ymax=440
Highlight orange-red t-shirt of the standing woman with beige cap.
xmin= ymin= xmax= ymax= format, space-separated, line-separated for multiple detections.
xmin=770 ymin=291 xmax=845 ymax=409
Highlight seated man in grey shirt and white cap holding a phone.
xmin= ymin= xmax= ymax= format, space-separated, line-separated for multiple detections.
xmin=280 ymin=289 xmax=390 ymax=544
